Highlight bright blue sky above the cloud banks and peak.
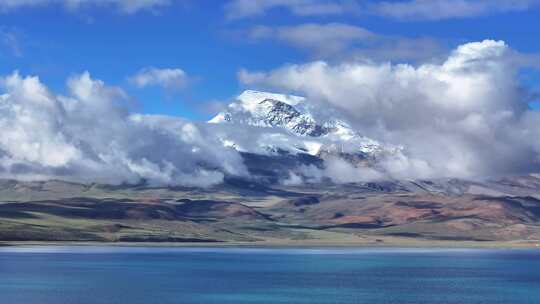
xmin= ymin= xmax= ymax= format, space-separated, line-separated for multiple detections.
xmin=0 ymin=0 xmax=540 ymax=120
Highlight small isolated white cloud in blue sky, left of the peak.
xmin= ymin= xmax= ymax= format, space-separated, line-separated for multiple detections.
xmin=129 ymin=67 xmax=189 ymax=90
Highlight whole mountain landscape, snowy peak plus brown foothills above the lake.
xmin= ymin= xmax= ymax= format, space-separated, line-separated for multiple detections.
xmin=0 ymin=91 xmax=540 ymax=247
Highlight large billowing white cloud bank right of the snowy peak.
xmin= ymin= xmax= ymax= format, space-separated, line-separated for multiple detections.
xmin=239 ymin=40 xmax=540 ymax=178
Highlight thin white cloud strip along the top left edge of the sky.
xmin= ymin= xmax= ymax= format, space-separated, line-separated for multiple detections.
xmin=0 ymin=0 xmax=172 ymax=14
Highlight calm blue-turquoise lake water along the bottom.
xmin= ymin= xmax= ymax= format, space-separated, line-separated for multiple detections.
xmin=0 ymin=247 xmax=540 ymax=304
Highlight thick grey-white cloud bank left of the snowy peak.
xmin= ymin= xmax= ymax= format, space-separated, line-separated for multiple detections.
xmin=0 ymin=72 xmax=246 ymax=186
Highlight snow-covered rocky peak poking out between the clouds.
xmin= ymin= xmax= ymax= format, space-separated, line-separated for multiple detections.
xmin=209 ymin=90 xmax=395 ymax=157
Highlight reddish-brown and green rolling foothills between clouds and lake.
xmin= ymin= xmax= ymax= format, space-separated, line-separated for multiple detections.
xmin=0 ymin=176 xmax=540 ymax=245
